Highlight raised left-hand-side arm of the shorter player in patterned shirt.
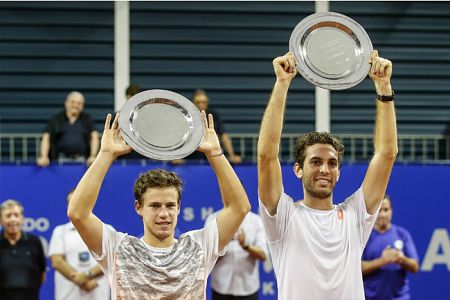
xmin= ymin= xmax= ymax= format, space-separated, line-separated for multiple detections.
xmin=67 ymin=114 xmax=131 ymax=254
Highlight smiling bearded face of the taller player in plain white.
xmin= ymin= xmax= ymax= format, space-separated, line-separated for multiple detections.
xmin=294 ymin=144 xmax=340 ymax=199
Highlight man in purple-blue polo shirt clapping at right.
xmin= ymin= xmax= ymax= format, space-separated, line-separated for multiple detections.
xmin=361 ymin=195 xmax=419 ymax=300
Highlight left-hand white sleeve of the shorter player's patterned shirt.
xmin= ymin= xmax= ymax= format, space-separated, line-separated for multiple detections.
xmin=90 ymin=223 xmax=125 ymax=275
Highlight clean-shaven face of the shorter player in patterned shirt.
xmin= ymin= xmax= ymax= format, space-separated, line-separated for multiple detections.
xmin=135 ymin=187 xmax=180 ymax=241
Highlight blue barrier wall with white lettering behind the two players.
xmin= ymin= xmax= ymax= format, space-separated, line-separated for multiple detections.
xmin=0 ymin=164 xmax=450 ymax=299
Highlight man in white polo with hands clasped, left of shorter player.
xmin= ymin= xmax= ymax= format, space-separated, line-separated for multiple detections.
xmin=48 ymin=191 xmax=110 ymax=300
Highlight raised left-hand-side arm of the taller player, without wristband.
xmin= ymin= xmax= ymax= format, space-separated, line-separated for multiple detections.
xmin=258 ymin=53 xmax=297 ymax=215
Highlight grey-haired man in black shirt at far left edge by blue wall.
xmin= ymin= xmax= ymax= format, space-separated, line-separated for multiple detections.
xmin=0 ymin=199 xmax=46 ymax=300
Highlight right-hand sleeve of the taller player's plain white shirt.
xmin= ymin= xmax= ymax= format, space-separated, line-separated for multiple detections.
xmin=342 ymin=186 xmax=381 ymax=250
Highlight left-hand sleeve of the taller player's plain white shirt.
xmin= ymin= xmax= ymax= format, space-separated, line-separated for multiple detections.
xmin=258 ymin=191 xmax=295 ymax=243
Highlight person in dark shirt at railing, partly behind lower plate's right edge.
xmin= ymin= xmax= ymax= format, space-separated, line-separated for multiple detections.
xmin=177 ymin=90 xmax=241 ymax=164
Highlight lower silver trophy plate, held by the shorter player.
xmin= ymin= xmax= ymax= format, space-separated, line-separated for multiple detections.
xmin=119 ymin=90 xmax=204 ymax=160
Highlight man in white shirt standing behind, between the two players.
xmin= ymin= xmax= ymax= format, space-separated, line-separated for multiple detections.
xmin=205 ymin=212 xmax=269 ymax=300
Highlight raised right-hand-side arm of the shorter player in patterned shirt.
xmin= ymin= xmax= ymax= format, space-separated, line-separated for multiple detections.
xmin=198 ymin=111 xmax=250 ymax=250
